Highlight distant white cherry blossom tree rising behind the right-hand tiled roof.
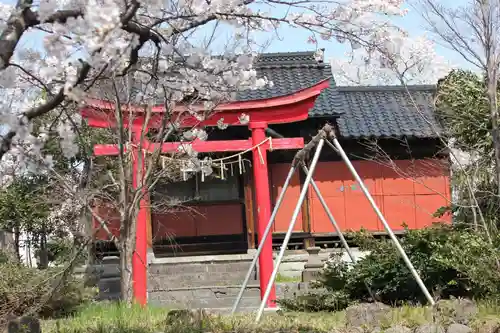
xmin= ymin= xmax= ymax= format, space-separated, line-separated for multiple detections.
xmin=331 ymin=34 xmax=451 ymax=86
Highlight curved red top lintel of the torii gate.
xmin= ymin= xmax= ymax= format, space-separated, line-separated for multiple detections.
xmin=81 ymin=79 xmax=329 ymax=128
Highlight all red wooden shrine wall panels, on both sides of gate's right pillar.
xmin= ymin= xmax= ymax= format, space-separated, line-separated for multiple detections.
xmin=94 ymin=160 xmax=451 ymax=239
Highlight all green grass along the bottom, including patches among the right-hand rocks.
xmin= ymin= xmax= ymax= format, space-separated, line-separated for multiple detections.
xmin=43 ymin=302 xmax=500 ymax=333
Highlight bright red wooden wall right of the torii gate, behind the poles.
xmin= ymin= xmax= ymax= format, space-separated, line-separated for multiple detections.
xmin=271 ymin=160 xmax=451 ymax=233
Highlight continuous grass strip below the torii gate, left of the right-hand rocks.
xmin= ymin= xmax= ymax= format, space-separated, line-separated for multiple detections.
xmin=42 ymin=303 xmax=344 ymax=333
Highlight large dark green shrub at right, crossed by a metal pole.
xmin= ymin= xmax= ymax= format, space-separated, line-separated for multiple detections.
xmin=280 ymin=224 xmax=500 ymax=311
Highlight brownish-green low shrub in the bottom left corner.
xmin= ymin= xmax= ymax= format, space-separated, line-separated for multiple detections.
xmin=0 ymin=263 xmax=94 ymax=321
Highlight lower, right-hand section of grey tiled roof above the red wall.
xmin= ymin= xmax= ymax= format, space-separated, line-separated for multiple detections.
xmin=331 ymin=86 xmax=441 ymax=138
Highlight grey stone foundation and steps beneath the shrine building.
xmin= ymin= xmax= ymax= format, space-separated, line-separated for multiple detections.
xmin=79 ymin=249 xmax=368 ymax=309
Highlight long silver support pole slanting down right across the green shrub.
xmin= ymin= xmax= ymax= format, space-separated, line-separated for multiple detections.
xmin=333 ymin=138 xmax=435 ymax=306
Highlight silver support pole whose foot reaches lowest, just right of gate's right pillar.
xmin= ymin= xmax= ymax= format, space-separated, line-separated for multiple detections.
xmin=255 ymin=139 xmax=325 ymax=323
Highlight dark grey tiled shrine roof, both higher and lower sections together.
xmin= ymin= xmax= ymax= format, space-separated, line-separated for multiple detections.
xmin=243 ymin=52 xmax=441 ymax=139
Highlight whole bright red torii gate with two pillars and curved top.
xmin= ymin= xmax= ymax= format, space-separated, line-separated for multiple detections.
xmin=81 ymin=79 xmax=329 ymax=307
